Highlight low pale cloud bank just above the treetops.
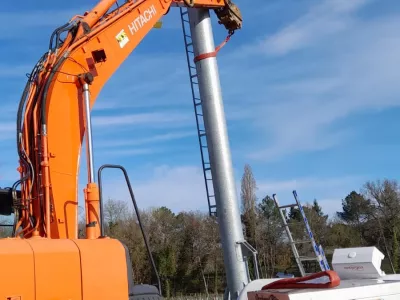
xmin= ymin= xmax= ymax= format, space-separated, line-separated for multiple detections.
xmin=94 ymin=165 xmax=364 ymax=216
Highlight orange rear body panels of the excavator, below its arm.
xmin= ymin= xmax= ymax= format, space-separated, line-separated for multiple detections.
xmin=0 ymin=237 xmax=128 ymax=300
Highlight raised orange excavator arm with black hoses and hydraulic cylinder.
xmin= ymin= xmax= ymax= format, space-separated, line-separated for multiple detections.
xmin=11 ymin=0 xmax=242 ymax=239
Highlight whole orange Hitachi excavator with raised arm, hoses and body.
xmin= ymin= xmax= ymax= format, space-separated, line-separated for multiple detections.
xmin=0 ymin=0 xmax=242 ymax=300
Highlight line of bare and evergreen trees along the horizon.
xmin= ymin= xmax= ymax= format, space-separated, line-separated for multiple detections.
xmin=0 ymin=165 xmax=400 ymax=297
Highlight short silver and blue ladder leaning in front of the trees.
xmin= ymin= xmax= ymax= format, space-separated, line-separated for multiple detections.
xmin=272 ymin=191 xmax=330 ymax=276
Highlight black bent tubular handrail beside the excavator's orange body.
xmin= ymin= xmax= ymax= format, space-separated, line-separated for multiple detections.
xmin=97 ymin=165 xmax=162 ymax=296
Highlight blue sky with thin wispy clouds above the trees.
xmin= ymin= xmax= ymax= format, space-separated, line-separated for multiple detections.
xmin=0 ymin=0 xmax=400 ymax=218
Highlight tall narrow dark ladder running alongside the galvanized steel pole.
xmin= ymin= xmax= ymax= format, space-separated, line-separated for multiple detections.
xmin=180 ymin=7 xmax=217 ymax=216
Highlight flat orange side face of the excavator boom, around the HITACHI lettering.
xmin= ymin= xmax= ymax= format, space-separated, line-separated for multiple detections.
xmin=46 ymin=0 xmax=169 ymax=238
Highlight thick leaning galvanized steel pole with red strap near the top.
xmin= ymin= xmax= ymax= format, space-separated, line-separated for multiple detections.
xmin=188 ymin=9 xmax=249 ymax=300
